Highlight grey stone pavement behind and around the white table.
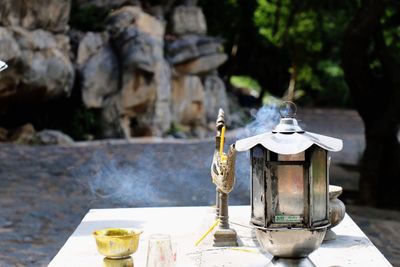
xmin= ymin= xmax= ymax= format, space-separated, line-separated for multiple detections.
xmin=0 ymin=110 xmax=400 ymax=266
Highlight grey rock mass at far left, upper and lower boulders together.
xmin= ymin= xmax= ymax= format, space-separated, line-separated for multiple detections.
xmin=0 ymin=0 xmax=75 ymax=112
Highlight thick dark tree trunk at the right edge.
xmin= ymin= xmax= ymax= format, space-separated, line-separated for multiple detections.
xmin=342 ymin=0 xmax=400 ymax=209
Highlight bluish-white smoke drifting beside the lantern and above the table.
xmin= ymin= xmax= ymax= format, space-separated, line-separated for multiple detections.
xmin=73 ymin=106 xmax=279 ymax=207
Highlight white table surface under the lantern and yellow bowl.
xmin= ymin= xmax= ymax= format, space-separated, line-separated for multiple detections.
xmin=49 ymin=206 xmax=392 ymax=267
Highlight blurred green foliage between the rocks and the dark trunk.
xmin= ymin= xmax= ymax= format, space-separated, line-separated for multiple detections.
xmin=200 ymin=0 xmax=360 ymax=106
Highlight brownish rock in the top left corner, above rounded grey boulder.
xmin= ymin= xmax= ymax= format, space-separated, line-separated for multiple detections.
xmin=0 ymin=0 xmax=71 ymax=32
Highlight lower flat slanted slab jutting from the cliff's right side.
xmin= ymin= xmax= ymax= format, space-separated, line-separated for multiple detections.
xmin=174 ymin=54 xmax=228 ymax=74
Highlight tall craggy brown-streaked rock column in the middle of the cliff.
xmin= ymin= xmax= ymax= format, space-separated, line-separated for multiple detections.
xmin=96 ymin=6 xmax=171 ymax=137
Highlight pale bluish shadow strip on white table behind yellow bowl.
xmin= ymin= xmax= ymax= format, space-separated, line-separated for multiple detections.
xmin=73 ymin=220 xmax=145 ymax=236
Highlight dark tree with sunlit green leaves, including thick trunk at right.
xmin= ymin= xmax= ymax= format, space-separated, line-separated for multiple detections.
xmin=200 ymin=0 xmax=400 ymax=208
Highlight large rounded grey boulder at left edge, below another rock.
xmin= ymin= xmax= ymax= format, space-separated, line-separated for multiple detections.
xmin=0 ymin=27 xmax=75 ymax=103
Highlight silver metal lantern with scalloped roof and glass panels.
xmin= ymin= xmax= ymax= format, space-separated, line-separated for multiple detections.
xmin=235 ymin=103 xmax=343 ymax=258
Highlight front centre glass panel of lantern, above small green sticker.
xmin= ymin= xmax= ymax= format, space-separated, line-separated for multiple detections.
xmin=275 ymin=165 xmax=304 ymax=220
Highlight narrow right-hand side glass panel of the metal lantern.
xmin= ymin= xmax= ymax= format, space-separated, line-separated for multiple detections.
xmin=311 ymin=148 xmax=328 ymax=222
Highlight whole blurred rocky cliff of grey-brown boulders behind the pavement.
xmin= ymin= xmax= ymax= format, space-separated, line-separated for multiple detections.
xmin=0 ymin=0 xmax=228 ymax=138
